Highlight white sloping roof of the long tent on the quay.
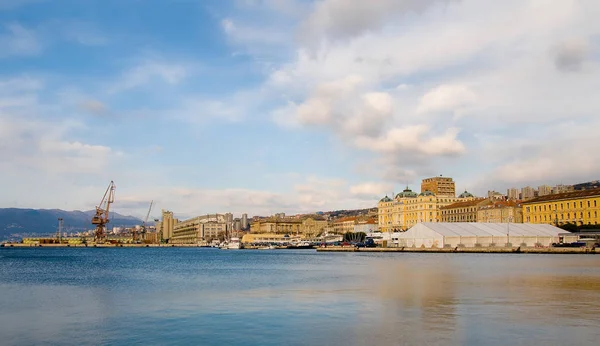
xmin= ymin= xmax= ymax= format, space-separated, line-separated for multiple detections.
xmin=405 ymin=222 xmax=565 ymax=237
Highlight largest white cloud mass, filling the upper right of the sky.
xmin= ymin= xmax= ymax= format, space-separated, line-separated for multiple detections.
xmin=266 ymin=0 xmax=600 ymax=188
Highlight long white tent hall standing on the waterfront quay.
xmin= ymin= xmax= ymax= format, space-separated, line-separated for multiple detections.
xmin=393 ymin=222 xmax=565 ymax=248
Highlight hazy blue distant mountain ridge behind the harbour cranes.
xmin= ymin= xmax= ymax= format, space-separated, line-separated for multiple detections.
xmin=0 ymin=208 xmax=142 ymax=239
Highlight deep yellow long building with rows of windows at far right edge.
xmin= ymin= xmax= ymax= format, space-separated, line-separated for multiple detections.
xmin=523 ymin=189 xmax=600 ymax=225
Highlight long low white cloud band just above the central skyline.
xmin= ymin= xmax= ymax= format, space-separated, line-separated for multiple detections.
xmin=110 ymin=176 xmax=376 ymax=218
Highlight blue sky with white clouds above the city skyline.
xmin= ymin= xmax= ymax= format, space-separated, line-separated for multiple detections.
xmin=0 ymin=0 xmax=600 ymax=218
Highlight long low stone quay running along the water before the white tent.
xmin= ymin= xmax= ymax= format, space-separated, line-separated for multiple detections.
xmin=317 ymin=246 xmax=600 ymax=254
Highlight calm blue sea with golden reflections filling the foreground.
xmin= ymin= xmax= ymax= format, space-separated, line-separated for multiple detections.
xmin=0 ymin=248 xmax=600 ymax=346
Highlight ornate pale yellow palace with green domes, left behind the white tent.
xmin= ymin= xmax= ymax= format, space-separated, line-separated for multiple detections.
xmin=377 ymin=187 xmax=475 ymax=232
